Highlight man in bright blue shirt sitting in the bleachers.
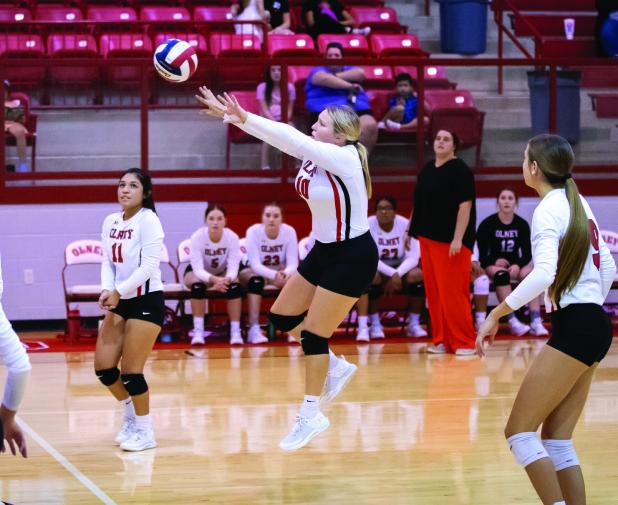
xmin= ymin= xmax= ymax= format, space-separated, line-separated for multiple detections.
xmin=305 ymin=42 xmax=378 ymax=152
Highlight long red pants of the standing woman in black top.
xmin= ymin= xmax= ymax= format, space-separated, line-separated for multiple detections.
xmin=419 ymin=237 xmax=476 ymax=352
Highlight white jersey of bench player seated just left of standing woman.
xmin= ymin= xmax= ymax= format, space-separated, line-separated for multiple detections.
xmin=369 ymin=215 xmax=421 ymax=277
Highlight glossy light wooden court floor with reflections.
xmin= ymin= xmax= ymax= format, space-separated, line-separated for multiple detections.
xmin=0 ymin=340 xmax=618 ymax=505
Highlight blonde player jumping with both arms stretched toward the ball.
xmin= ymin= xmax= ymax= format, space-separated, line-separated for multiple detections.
xmin=197 ymin=87 xmax=378 ymax=451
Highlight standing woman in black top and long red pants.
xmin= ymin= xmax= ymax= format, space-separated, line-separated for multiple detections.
xmin=408 ymin=130 xmax=476 ymax=356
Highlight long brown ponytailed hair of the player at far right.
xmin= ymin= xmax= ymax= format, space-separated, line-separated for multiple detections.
xmin=528 ymin=134 xmax=590 ymax=303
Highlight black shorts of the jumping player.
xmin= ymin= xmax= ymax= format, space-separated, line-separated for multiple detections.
xmin=298 ymin=232 xmax=378 ymax=298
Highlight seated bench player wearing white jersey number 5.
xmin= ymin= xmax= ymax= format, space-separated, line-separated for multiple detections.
xmin=183 ymin=204 xmax=243 ymax=345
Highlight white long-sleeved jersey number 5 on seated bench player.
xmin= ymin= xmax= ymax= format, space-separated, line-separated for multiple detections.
xmin=191 ymin=226 xmax=240 ymax=282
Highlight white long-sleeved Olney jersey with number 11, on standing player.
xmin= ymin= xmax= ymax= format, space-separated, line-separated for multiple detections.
xmin=101 ymin=208 xmax=165 ymax=299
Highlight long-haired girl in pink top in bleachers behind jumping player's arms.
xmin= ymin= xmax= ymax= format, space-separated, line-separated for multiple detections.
xmin=256 ymin=65 xmax=296 ymax=170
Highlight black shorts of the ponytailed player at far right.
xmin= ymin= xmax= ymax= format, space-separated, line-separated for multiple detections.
xmin=547 ymin=303 xmax=613 ymax=366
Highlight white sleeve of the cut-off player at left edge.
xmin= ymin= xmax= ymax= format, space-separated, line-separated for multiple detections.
xmin=0 ymin=254 xmax=32 ymax=412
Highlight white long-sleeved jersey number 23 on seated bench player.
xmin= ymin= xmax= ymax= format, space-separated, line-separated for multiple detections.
xmin=245 ymin=223 xmax=298 ymax=280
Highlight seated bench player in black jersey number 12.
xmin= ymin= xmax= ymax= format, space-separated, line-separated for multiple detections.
xmin=476 ymin=188 xmax=548 ymax=336
